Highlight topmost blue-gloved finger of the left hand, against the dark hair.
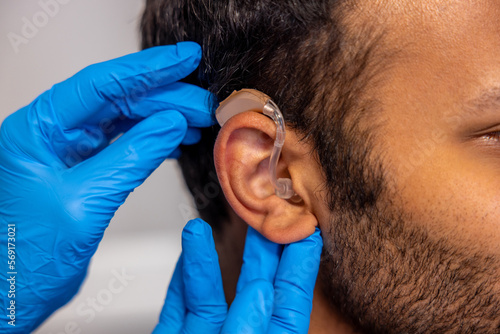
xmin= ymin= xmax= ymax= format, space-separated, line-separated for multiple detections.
xmin=49 ymin=42 xmax=201 ymax=129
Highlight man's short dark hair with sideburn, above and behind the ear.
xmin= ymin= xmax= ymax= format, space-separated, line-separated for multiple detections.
xmin=142 ymin=0 xmax=382 ymax=230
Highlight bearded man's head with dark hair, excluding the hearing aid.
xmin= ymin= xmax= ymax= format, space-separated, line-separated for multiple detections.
xmin=143 ymin=0 xmax=500 ymax=333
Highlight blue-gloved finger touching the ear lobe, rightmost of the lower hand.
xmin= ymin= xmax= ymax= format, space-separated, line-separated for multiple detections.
xmin=269 ymin=229 xmax=323 ymax=334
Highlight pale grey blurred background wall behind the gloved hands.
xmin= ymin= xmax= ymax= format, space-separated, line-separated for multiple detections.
xmin=0 ymin=0 xmax=199 ymax=334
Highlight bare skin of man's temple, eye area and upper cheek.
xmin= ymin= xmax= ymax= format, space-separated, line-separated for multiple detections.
xmin=364 ymin=1 xmax=500 ymax=257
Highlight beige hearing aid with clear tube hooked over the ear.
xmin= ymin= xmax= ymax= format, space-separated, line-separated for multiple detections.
xmin=215 ymin=89 xmax=295 ymax=199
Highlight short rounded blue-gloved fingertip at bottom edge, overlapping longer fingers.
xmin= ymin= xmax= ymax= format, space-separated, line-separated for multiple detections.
xmin=221 ymin=279 xmax=274 ymax=334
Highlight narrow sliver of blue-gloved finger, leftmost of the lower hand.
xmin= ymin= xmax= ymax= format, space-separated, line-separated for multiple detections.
xmin=153 ymin=254 xmax=186 ymax=334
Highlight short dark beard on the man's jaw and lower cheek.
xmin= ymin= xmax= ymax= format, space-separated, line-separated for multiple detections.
xmin=318 ymin=208 xmax=500 ymax=333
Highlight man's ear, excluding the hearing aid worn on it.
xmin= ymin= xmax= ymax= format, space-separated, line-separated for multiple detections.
xmin=214 ymin=111 xmax=318 ymax=244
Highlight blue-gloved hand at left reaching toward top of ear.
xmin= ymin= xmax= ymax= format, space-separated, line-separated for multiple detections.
xmin=0 ymin=42 xmax=212 ymax=333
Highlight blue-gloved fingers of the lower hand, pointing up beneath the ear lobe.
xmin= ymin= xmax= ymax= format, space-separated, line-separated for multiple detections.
xmin=153 ymin=219 xmax=323 ymax=334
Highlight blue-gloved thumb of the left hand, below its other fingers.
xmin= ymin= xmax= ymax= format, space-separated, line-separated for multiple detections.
xmin=72 ymin=111 xmax=187 ymax=233
